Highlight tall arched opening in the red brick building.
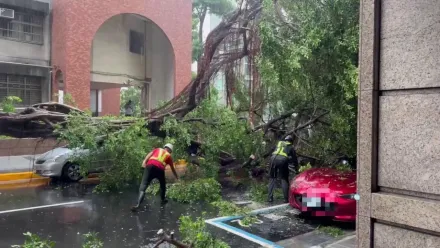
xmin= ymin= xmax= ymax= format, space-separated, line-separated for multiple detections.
xmin=90 ymin=13 xmax=175 ymax=115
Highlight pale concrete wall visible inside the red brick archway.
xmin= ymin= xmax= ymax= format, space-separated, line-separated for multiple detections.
xmin=91 ymin=14 xmax=175 ymax=109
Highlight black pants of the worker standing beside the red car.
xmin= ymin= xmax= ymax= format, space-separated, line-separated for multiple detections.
xmin=269 ymin=160 xmax=289 ymax=202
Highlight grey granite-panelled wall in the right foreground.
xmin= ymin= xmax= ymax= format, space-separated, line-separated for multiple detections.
xmin=357 ymin=0 xmax=440 ymax=248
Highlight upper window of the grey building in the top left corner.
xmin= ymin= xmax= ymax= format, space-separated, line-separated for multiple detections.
xmin=0 ymin=12 xmax=44 ymax=44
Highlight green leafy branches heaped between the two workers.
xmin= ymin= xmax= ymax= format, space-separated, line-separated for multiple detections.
xmin=162 ymin=89 xmax=265 ymax=174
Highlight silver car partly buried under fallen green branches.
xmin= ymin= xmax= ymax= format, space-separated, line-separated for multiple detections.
xmin=34 ymin=147 xmax=102 ymax=182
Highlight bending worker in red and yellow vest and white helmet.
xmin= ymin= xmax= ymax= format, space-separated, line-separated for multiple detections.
xmin=131 ymin=144 xmax=179 ymax=211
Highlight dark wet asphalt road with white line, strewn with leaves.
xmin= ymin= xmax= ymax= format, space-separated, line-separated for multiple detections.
xmin=0 ymin=184 xmax=258 ymax=248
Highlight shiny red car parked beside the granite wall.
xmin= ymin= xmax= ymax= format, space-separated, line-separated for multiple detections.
xmin=289 ymin=168 xmax=359 ymax=221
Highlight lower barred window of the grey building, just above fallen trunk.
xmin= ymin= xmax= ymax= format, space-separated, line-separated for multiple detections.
xmin=0 ymin=74 xmax=42 ymax=107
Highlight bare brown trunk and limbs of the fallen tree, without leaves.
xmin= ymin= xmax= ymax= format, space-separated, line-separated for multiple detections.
xmin=0 ymin=0 xmax=262 ymax=138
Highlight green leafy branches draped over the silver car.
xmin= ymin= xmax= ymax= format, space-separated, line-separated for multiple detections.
xmin=58 ymin=114 xmax=162 ymax=191
